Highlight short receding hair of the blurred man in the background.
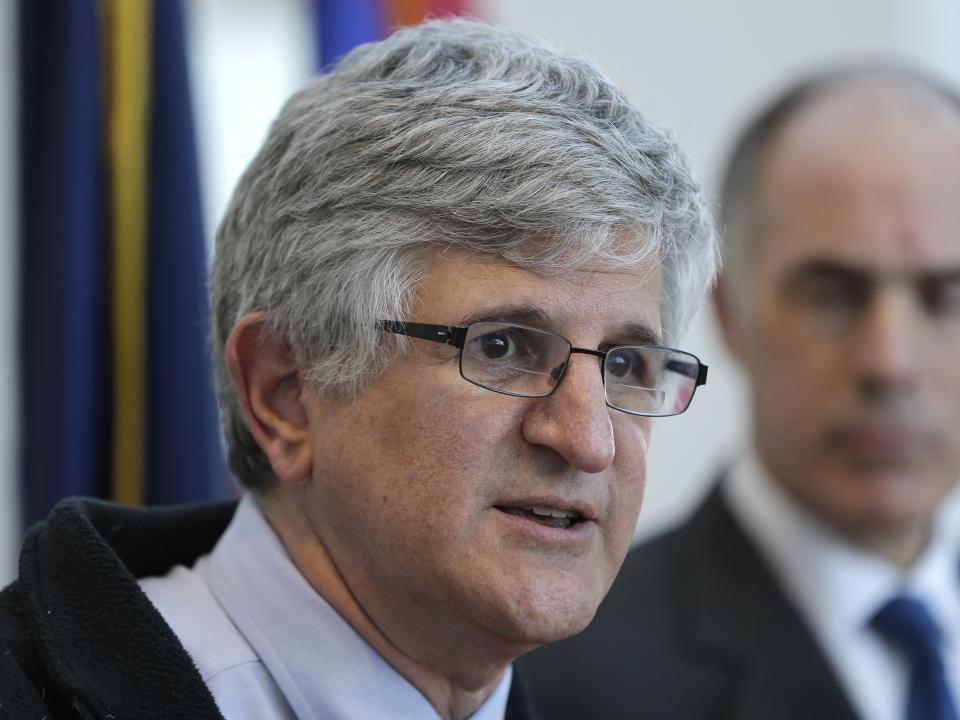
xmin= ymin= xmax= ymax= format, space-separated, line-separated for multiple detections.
xmin=719 ymin=59 xmax=960 ymax=315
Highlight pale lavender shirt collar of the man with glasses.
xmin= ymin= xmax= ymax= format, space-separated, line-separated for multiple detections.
xmin=206 ymin=496 xmax=512 ymax=720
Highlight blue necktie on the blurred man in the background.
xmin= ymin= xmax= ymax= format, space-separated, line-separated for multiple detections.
xmin=871 ymin=596 xmax=960 ymax=720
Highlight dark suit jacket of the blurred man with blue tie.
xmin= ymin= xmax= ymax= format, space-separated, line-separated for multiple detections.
xmin=521 ymin=488 xmax=856 ymax=720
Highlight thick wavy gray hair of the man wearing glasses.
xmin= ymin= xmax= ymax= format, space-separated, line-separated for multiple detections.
xmin=211 ymin=20 xmax=718 ymax=491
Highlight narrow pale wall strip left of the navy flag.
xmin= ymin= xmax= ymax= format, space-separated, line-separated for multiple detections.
xmin=0 ymin=0 xmax=20 ymax=586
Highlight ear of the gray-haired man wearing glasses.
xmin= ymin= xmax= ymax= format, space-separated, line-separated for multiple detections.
xmin=225 ymin=311 xmax=312 ymax=483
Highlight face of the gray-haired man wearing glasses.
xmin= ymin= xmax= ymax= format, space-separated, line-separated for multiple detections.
xmin=304 ymin=255 xmax=660 ymax=645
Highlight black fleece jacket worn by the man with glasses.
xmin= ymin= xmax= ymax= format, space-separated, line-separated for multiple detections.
xmin=0 ymin=499 xmax=533 ymax=720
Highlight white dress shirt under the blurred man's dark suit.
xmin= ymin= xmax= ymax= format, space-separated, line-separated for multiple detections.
xmin=723 ymin=454 xmax=960 ymax=720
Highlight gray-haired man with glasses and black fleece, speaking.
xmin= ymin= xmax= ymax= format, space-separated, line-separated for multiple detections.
xmin=0 ymin=21 xmax=717 ymax=720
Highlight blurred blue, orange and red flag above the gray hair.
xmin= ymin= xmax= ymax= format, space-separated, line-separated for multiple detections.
xmin=313 ymin=0 xmax=475 ymax=68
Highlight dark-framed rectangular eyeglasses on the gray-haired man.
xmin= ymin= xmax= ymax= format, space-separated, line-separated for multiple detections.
xmin=379 ymin=320 xmax=707 ymax=417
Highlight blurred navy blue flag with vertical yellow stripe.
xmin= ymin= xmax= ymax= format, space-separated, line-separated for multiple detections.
xmin=19 ymin=0 xmax=229 ymax=525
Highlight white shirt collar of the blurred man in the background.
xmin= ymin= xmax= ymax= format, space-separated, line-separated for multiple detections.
xmin=724 ymin=452 xmax=960 ymax=637
